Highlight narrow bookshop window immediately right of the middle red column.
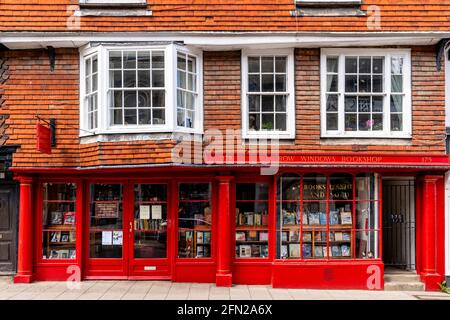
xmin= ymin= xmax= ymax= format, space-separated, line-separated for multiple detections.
xmin=236 ymin=183 xmax=269 ymax=258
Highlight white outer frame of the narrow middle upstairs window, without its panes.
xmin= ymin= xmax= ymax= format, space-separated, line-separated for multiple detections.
xmin=241 ymin=48 xmax=295 ymax=139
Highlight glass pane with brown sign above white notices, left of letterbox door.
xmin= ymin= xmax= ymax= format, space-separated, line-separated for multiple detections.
xmin=89 ymin=184 xmax=123 ymax=258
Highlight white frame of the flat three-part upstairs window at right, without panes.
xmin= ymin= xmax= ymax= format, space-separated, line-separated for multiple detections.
xmin=320 ymin=48 xmax=412 ymax=139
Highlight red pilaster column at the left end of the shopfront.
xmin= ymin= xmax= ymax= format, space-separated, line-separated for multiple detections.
xmin=14 ymin=177 xmax=34 ymax=283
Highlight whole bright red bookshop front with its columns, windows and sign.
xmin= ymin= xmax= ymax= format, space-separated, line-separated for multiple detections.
xmin=12 ymin=154 xmax=450 ymax=290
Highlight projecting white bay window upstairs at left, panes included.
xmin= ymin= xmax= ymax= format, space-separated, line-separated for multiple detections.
xmin=80 ymin=44 xmax=202 ymax=136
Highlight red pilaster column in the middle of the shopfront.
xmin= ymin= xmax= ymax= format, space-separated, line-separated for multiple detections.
xmin=216 ymin=176 xmax=233 ymax=287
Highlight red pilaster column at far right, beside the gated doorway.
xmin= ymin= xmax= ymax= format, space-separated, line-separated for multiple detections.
xmin=418 ymin=175 xmax=443 ymax=290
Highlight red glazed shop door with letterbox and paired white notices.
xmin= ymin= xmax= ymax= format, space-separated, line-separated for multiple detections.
xmin=129 ymin=183 xmax=170 ymax=278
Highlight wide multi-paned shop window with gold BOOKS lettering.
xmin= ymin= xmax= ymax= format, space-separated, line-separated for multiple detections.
xmin=277 ymin=174 xmax=379 ymax=259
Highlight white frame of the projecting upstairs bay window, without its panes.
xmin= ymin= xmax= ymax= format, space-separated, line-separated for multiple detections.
xmin=79 ymin=43 xmax=203 ymax=137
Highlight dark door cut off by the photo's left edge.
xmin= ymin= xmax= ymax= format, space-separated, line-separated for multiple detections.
xmin=0 ymin=185 xmax=17 ymax=273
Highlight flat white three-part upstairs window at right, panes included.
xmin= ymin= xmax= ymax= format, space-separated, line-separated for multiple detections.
xmin=321 ymin=49 xmax=411 ymax=138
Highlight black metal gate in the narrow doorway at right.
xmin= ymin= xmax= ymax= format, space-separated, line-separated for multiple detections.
xmin=383 ymin=179 xmax=416 ymax=270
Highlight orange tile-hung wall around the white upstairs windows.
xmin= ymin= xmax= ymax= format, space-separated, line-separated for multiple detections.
xmin=0 ymin=47 xmax=445 ymax=167
